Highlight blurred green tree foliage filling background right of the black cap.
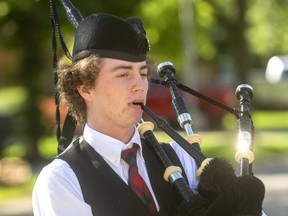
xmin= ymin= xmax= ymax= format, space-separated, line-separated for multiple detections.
xmin=138 ymin=0 xmax=288 ymax=83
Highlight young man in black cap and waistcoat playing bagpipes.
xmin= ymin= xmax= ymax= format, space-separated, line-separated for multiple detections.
xmin=33 ymin=14 xmax=261 ymax=216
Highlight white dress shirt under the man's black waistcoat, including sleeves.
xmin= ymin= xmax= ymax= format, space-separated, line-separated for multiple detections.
xmin=32 ymin=125 xmax=198 ymax=216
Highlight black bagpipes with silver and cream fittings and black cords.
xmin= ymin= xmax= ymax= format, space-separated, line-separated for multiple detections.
xmin=50 ymin=0 xmax=265 ymax=216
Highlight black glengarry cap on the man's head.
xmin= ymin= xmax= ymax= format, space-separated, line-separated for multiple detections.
xmin=72 ymin=13 xmax=149 ymax=62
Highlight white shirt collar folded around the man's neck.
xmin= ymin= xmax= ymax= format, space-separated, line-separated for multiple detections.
xmin=83 ymin=124 xmax=144 ymax=167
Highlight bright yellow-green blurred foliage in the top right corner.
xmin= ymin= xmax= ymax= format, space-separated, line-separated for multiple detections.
xmin=247 ymin=0 xmax=288 ymax=63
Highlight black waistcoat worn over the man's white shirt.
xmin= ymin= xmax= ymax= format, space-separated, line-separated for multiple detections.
xmin=59 ymin=140 xmax=181 ymax=216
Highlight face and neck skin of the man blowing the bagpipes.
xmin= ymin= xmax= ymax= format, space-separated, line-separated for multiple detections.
xmin=86 ymin=58 xmax=148 ymax=132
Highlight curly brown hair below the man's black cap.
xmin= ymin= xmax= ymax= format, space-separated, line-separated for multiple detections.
xmin=56 ymin=55 xmax=102 ymax=124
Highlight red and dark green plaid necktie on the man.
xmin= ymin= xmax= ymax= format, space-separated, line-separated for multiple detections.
xmin=121 ymin=143 xmax=157 ymax=215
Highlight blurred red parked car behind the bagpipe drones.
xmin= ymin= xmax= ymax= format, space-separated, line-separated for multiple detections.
xmin=143 ymin=80 xmax=235 ymax=129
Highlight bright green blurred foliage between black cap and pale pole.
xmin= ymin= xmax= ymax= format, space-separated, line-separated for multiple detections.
xmin=139 ymin=0 xmax=183 ymax=64
